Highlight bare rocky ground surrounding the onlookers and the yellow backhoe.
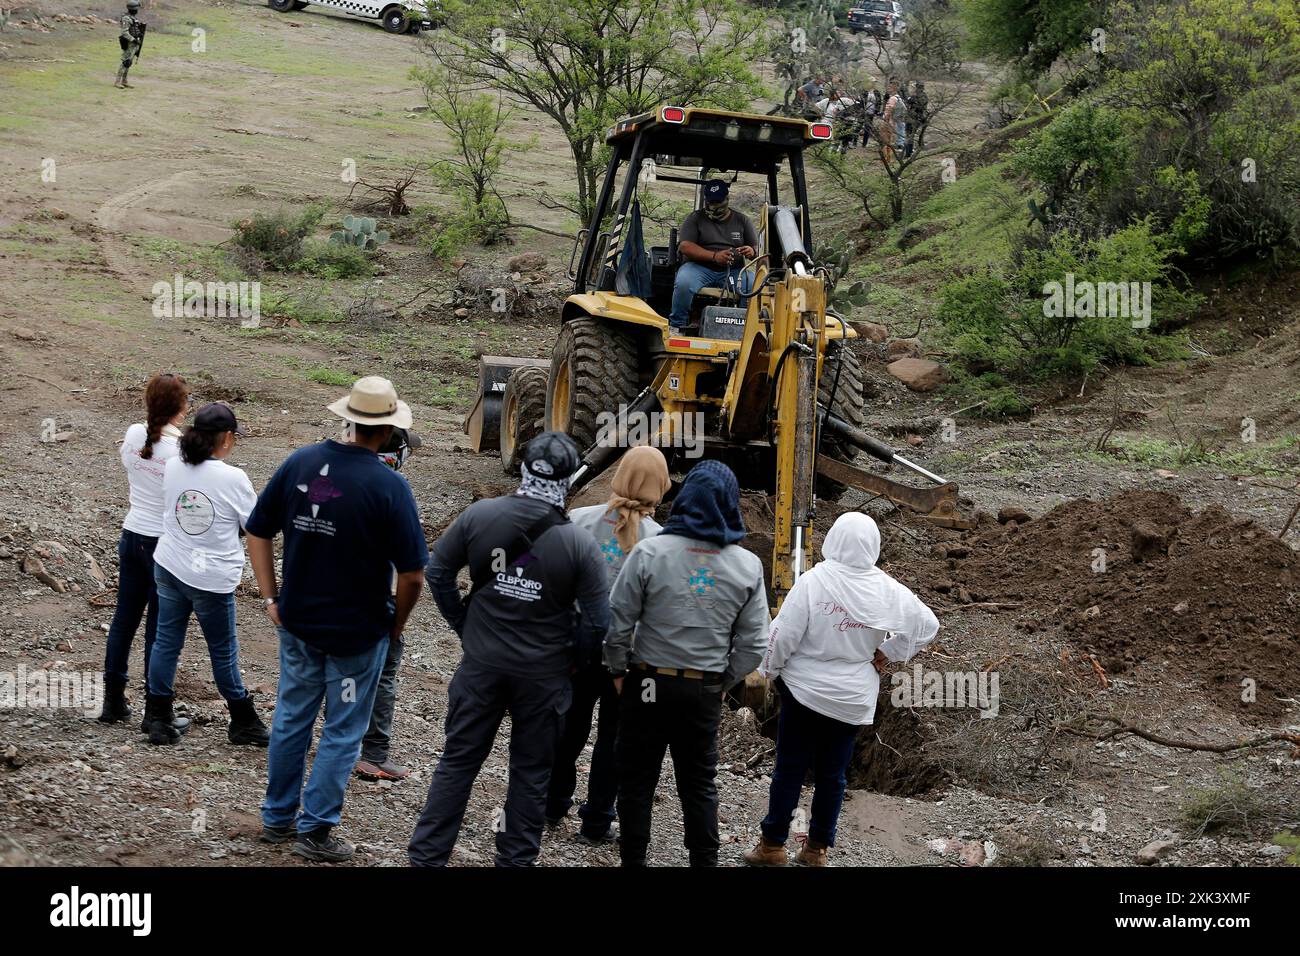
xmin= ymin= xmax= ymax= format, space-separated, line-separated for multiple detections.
xmin=0 ymin=1 xmax=1300 ymax=866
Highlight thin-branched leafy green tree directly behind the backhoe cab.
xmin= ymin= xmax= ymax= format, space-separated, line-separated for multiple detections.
xmin=424 ymin=0 xmax=768 ymax=221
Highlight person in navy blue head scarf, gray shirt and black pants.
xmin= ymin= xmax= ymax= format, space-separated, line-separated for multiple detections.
xmin=605 ymin=460 xmax=770 ymax=866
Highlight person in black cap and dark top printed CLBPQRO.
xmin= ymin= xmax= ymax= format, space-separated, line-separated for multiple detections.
xmin=408 ymin=432 xmax=610 ymax=866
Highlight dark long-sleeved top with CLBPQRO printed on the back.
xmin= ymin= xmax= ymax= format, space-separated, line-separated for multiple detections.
xmin=425 ymin=494 xmax=610 ymax=678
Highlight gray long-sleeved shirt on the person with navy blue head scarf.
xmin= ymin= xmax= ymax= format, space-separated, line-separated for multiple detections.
xmin=605 ymin=535 xmax=771 ymax=687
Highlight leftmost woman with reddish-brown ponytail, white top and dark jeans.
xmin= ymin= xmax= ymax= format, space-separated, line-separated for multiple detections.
xmin=99 ymin=372 xmax=190 ymax=732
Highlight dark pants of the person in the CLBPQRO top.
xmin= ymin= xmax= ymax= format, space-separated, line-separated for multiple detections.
xmin=408 ymin=659 xmax=572 ymax=866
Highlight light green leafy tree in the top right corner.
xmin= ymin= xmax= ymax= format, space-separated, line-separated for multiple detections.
xmin=1100 ymin=0 xmax=1300 ymax=258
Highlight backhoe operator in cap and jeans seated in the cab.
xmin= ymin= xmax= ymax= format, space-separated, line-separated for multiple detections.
xmin=668 ymin=179 xmax=758 ymax=329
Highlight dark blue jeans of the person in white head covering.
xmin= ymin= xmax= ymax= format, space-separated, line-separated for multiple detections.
xmin=762 ymin=680 xmax=858 ymax=847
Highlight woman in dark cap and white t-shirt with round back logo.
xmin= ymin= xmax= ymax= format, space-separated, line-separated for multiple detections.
xmin=144 ymin=402 xmax=269 ymax=747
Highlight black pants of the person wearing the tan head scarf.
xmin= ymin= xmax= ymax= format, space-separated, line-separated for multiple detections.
xmin=546 ymin=663 xmax=619 ymax=838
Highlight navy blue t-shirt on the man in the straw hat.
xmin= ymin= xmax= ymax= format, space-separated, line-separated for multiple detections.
xmin=247 ymin=441 xmax=429 ymax=656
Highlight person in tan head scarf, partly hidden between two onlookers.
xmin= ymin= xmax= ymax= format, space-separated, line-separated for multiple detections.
xmin=546 ymin=445 xmax=672 ymax=844
